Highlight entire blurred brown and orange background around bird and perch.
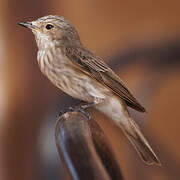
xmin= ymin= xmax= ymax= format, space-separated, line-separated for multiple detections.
xmin=0 ymin=0 xmax=180 ymax=180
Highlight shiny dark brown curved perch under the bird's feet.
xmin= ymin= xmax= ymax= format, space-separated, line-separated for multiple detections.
xmin=55 ymin=112 xmax=123 ymax=180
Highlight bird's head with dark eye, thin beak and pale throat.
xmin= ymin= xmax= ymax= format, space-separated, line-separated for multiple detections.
xmin=18 ymin=15 xmax=80 ymax=48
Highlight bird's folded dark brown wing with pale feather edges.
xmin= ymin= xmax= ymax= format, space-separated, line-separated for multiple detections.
xmin=66 ymin=48 xmax=146 ymax=112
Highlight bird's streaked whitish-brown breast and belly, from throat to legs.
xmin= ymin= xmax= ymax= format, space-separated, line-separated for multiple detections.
xmin=38 ymin=51 xmax=109 ymax=102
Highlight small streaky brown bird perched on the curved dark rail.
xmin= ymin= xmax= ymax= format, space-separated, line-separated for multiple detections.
xmin=18 ymin=15 xmax=161 ymax=165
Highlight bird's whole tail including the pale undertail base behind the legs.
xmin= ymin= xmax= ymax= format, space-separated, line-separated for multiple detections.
xmin=97 ymin=98 xmax=161 ymax=165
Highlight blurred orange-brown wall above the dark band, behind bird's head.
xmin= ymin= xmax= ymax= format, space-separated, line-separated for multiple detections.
xmin=53 ymin=0 xmax=180 ymax=55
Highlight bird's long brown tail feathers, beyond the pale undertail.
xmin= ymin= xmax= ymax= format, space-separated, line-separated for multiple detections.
xmin=122 ymin=118 xmax=161 ymax=166
